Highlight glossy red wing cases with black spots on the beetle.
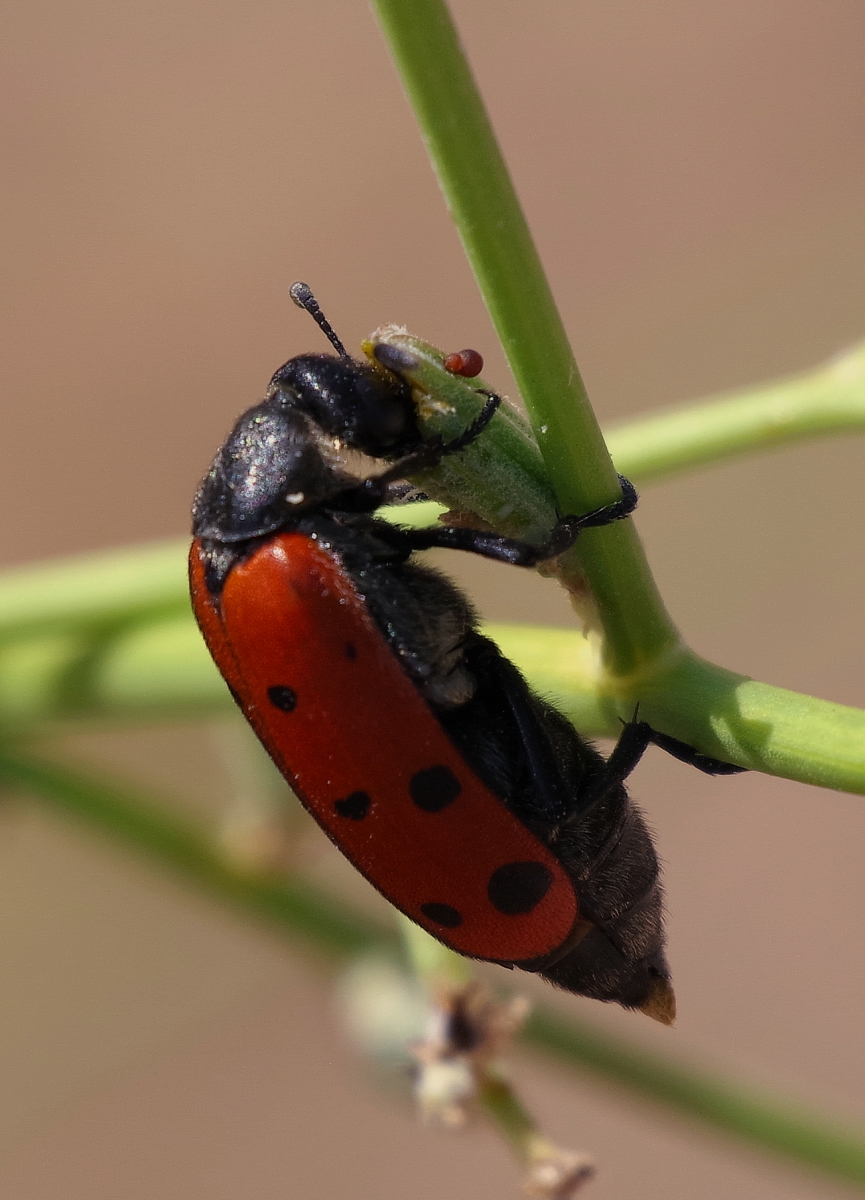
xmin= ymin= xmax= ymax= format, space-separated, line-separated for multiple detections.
xmin=190 ymin=533 xmax=578 ymax=964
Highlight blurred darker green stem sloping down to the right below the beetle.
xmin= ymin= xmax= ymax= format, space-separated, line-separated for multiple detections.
xmin=0 ymin=748 xmax=865 ymax=1188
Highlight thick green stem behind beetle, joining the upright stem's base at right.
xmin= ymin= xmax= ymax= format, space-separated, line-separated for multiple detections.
xmin=0 ymin=564 xmax=865 ymax=794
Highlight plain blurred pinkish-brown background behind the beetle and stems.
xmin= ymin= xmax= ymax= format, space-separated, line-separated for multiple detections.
xmin=0 ymin=0 xmax=865 ymax=1200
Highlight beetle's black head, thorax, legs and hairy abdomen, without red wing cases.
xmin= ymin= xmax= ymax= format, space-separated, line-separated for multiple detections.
xmin=193 ymin=284 xmax=738 ymax=1021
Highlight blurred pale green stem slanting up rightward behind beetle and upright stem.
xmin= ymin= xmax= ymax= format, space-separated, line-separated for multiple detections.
xmin=0 ymin=340 xmax=865 ymax=647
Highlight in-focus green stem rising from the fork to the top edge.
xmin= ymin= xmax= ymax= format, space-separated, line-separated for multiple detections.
xmin=374 ymin=0 xmax=679 ymax=676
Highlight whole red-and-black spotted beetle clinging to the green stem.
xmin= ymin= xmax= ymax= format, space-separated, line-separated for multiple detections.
xmin=190 ymin=284 xmax=739 ymax=1024
